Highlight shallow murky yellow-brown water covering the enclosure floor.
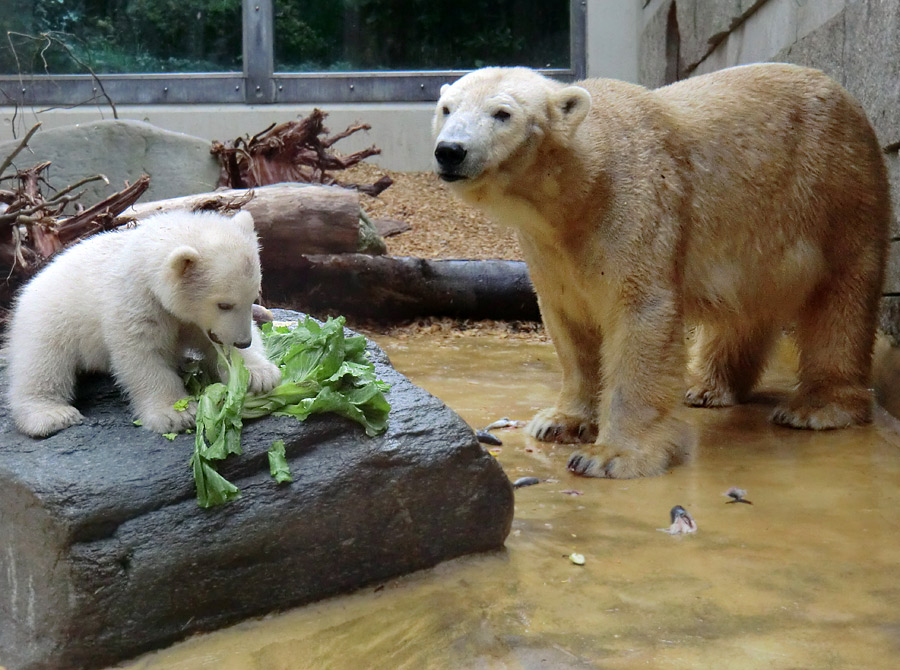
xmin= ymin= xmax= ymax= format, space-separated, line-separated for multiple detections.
xmin=121 ymin=337 xmax=900 ymax=670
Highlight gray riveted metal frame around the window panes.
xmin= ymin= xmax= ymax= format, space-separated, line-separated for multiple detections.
xmin=0 ymin=0 xmax=587 ymax=107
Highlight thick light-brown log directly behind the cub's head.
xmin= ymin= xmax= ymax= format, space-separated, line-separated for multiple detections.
xmin=123 ymin=183 xmax=360 ymax=262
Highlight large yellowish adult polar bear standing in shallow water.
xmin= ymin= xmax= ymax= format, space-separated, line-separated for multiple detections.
xmin=434 ymin=64 xmax=891 ymax=477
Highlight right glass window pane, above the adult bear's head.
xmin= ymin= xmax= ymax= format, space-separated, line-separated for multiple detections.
xmin=274 ymin=0 xmax=570 ymax=72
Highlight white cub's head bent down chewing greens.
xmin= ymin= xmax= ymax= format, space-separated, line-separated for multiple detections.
xmin=160 ymin=212 xmax=261 ymax=349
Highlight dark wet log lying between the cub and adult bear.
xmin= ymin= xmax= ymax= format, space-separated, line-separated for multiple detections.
xmin=263 ymin=254 xmax=540 ymax=322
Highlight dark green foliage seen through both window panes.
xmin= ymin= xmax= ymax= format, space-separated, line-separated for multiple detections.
xmin=0 ymin=0 xmax=569 ymax=74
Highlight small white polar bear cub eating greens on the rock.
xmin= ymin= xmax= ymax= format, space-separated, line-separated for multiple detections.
xmin=8 ymin=212 xmax=281 ymax=437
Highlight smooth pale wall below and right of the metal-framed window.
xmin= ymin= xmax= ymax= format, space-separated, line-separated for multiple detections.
xmin=0 ymin=0 xmax=640 ymax=170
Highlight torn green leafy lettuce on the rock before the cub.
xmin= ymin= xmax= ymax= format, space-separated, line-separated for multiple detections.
xmin=186 ymin=317 xmax=391 ymax=507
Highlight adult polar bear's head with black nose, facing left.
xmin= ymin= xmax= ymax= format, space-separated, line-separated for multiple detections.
xmin=432 ymin=67 xmax=591 ymax=191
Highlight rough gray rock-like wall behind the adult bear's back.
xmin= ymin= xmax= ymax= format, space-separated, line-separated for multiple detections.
xmin=638 ymin=0 xmax=900 ymax=337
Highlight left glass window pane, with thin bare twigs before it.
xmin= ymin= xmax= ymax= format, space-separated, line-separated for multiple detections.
xmin=0 ymin=0 xmax=242 ymax=74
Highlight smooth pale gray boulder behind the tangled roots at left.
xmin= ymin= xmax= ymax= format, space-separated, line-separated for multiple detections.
xmin=0 ymin=121 xmax=219 ymax=206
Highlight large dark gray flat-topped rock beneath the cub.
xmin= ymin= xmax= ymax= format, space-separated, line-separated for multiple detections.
xmin=0 ymin=314 xmax=513 ymax=670
